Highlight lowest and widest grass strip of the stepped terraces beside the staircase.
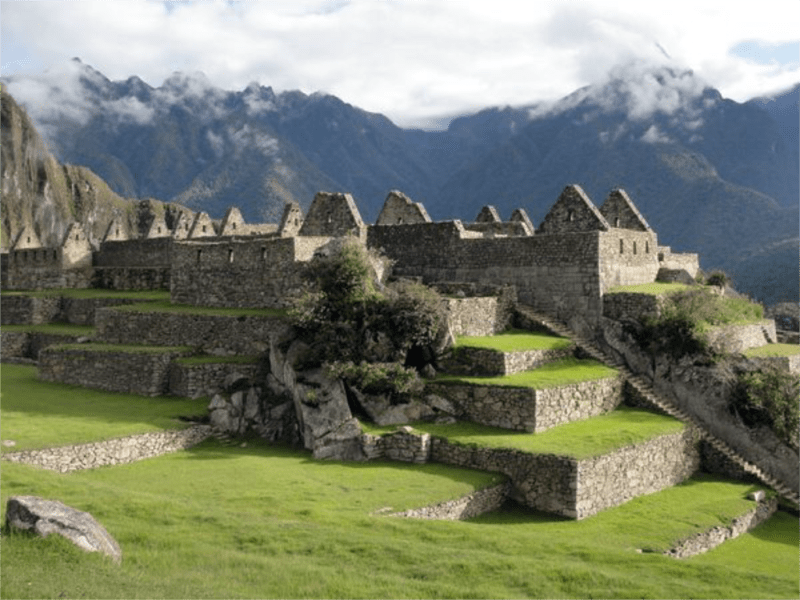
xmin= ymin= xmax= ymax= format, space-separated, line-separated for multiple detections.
xmin=362 ymin=407 xmax=684 ymax=459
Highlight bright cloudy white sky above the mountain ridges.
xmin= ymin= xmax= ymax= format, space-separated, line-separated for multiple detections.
xmin=0 ymin=0 xmax=800 ymax=128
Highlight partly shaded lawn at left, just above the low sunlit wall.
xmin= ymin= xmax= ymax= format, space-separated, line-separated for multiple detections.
xmin=0 ymin=364 xmax=208 ymax=452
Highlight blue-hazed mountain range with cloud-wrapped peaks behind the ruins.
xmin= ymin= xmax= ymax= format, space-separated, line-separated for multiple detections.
xmin=7 ymin=60 xmax=800 ymax=301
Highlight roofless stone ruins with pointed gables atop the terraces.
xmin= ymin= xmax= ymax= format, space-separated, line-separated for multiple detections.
xmin=4 ymin=185 xmax=698 ymax=323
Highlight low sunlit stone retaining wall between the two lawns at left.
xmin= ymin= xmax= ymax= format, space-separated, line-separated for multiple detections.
xmin=2 ymin=425 xmax=211 ymax=473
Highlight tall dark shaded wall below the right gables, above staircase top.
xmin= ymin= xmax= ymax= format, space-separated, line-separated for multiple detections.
xmin=367 ymin=221 xmax=604 ymax=321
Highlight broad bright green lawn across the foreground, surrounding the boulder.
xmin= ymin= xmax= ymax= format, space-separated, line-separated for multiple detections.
xmin=0 ymin=365 xmax=800 ymax=600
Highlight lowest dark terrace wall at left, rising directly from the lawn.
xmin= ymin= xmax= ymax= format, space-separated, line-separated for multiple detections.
xmin=39 ymin=346 xmax=189 ymax=396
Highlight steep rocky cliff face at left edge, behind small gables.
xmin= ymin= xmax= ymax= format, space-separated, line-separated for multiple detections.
xmin=0 ymin=89 xmax=188 ymax=250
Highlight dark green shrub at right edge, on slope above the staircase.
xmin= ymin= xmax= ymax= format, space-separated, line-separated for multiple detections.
xmin=731 ymin=365 xmax=800 ymax=448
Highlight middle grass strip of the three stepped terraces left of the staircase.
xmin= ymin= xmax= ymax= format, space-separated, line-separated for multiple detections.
xmin=434 ymin=358 xmax=617 ymax=390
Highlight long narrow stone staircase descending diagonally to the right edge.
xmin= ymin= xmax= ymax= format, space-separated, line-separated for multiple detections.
xmin=517 ymin=305 xmax=800 ymax=504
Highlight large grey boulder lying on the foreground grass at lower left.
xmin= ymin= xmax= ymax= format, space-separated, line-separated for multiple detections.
xmin=6 ymin=496 xmax=122 ymax=563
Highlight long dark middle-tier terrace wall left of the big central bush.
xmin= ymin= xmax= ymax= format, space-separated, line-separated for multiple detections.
xmin=96 ymin=308 xmax=289 ymax=355
